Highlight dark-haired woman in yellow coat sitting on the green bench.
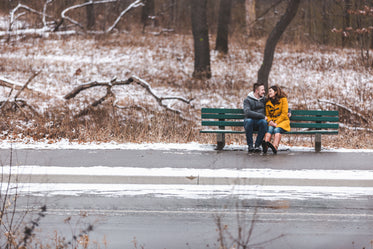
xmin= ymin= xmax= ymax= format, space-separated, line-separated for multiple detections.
xmin=262 ymin=86 xmax=290 ymax=154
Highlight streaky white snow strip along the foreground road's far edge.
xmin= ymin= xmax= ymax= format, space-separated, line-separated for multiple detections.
xmin=3 ymin=183 xmax=373 ymax=200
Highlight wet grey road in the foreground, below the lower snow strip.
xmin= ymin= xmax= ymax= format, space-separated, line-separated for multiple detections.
xmin=19 ymin=196 xmax=373 ymax=249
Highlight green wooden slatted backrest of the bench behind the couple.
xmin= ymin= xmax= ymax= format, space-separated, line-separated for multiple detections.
xmin=201 ymin=108 xmax=339 ymax=132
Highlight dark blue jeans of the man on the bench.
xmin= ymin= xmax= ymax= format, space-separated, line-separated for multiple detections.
xmin=243 ymin=118 xmax=267 ymax=147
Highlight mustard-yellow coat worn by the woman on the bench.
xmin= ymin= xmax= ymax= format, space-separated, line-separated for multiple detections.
xmin=266 ymin=98 xmax=290 ymax=131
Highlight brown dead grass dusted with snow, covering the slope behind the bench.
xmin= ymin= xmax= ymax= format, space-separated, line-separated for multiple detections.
xmin=0 ymin=33 xmax=373 ymax=148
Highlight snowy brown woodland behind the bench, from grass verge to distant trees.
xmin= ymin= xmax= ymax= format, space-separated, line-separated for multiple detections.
xmin=0 ymin=0 xmax=373 ymax=148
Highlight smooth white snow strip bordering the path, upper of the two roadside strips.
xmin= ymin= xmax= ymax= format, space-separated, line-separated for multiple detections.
xmin=6 ymin=165 xmax=373 ymax=180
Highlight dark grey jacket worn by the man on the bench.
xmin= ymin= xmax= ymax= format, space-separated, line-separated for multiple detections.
xmin=243 ymin=92 xmax=265 ymax=119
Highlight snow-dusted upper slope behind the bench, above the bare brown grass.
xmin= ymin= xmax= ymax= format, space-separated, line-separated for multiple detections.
xmin=0 ymin=35 xmax=373 ymax=114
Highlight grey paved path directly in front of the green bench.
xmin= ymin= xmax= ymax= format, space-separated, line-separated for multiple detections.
xmin=0 ymin=147 xmax=373 ymax=170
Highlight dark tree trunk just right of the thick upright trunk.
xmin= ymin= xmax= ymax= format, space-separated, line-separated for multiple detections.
xmin=215 ymin=0 xmax=232 ymax=54
